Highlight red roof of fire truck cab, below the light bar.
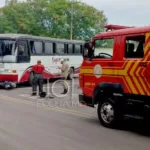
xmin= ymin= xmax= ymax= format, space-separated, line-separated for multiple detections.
xmin=94 ymin=26 xmax=150 ymax=39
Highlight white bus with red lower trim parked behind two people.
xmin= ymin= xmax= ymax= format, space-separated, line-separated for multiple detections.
xmin=0 ymin=34 xmax=84 ymax=83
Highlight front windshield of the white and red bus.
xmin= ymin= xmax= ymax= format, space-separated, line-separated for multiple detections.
xmin=0 ymin=39 xmax=15 ymax=56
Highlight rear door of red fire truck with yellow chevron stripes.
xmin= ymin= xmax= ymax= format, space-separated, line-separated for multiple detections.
xmin=124 ymin=34 xmax=150 ymax=95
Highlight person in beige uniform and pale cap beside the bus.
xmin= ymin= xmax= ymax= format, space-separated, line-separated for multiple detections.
xmin=58 ymin=59 xmax=69 ymax=94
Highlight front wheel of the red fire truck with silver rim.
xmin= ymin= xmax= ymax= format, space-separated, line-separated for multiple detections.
xmin=97 ymin=98 xmax=117 ymax=128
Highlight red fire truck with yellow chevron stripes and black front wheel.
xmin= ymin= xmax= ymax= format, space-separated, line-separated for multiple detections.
xmin=79 ymin=25 xmax=150 ymax=127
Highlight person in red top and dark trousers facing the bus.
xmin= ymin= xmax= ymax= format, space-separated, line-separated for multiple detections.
xmin=32 ymin=60 xmax=45 ymax=96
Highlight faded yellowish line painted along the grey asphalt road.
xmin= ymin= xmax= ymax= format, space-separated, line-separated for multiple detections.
xmin=0 ymin=94 xmax=95 ymax=119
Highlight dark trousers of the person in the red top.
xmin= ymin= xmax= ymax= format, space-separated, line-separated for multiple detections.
xmin=32 ymin=73 xmax=44 ymax=93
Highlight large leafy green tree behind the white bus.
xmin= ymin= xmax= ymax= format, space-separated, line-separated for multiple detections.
xmin=0 ymin=0 xmax=107 ymax=39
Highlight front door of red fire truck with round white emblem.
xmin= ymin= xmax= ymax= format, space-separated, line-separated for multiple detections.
xmin=82 ymin=38 xmax=114 ymax=96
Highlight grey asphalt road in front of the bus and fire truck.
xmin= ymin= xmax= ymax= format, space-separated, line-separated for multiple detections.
xmin=0 ymin=79 xmax=150 ymax=150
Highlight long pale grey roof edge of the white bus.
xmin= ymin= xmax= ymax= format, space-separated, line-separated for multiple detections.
xmin=0 ymin=33 xmax=84 ymax=43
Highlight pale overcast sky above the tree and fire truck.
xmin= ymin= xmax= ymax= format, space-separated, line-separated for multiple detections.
xmin=0 ymin=0 xmax=150 ymax=26
